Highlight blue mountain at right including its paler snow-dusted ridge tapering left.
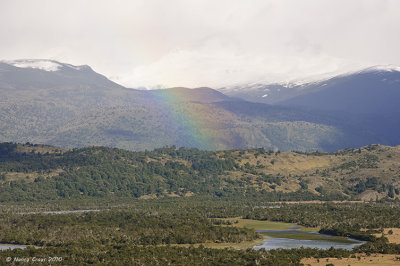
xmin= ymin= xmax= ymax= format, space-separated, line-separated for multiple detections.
xmin=223 ymin=66 xmax=400 ymax=147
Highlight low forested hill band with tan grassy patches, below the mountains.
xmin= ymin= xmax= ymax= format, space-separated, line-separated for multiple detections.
xmin=0 ymin=143 xmax=400 ymax=201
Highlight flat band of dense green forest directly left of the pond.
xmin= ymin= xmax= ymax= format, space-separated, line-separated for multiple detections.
xmin=0 ymin=210 xmax=260 ymax=246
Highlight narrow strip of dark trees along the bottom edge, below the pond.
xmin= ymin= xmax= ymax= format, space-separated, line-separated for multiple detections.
xmin=0 ymin=245 xmax=356 ymax=265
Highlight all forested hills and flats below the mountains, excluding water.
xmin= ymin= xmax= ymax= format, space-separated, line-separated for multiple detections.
xmin=0 ymin=143 xmax=400 ymax=265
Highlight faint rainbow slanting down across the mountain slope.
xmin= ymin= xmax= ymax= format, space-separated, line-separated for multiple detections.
xmin=149 ymin=89 xmax=218 ymax=150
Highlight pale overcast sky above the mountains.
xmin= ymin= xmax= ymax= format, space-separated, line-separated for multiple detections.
xmin=0 ymin=0 xmax=400 ymax=88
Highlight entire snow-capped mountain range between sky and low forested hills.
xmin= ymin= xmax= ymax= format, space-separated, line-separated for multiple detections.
xmin=0 ymin=60 xmax=400 ymax=151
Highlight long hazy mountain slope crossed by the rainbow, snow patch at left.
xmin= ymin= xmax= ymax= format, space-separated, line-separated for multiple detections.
xmin=0 ymin=60 xmax=394 ymax=151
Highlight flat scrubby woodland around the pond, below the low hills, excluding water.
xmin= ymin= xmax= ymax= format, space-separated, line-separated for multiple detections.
xmin=0 ymin=197 xmax=400 ymax=265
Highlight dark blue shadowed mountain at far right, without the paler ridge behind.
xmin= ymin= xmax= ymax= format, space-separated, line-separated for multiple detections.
xmin=279 ymin=67 xmax=400 ymax=145
